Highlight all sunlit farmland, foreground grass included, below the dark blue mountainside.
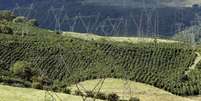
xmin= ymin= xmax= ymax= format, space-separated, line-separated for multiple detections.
xmin=0 ymin=12 xmax=201 ymax=101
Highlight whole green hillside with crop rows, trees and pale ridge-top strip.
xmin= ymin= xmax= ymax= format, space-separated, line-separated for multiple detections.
xmin=0 ymin=11 xmax=201 ymax=96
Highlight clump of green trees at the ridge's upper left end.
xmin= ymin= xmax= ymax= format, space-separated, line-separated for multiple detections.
xmin=0 ymin=10 xmax=38 ymax=35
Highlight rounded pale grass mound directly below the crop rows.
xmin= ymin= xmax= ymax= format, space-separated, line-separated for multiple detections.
xmin=70 ymin=78 xmax=196 ymax=101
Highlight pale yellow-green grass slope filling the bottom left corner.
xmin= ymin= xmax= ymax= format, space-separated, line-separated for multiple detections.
xmin=0 ymin=85 xmax=102 ymax=101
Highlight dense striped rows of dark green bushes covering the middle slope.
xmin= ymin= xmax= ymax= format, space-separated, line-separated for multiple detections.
xmin=0 ymin=30 xmax=200 ymax=95
